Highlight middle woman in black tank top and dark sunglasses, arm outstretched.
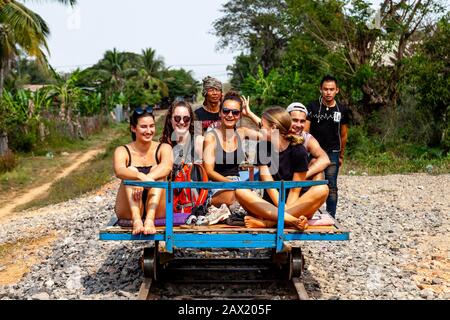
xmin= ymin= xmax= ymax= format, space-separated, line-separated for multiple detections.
xmin=203 ymin=91 xmax=262 ymax=207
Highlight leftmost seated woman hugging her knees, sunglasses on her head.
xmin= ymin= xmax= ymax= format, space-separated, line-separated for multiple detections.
xmin=113 ymin=107 xmax=173 ymax=235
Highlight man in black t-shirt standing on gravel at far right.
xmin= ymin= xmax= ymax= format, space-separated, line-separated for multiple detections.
xmin=305 ymin=76 xmax=349 ymax=217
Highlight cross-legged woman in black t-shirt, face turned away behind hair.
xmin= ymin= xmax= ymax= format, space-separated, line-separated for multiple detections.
xmin=236 ymin=107 xmax=328 ymax=230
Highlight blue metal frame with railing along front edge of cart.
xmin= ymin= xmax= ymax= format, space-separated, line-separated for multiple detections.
xmin=100 ymin=180 xmax=349 ymax=253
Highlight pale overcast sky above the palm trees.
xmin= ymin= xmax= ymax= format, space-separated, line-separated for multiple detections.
xmin=27 ymin=0 xmax=238 ymax=81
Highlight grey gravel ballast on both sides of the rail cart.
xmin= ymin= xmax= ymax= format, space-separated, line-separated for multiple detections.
xmin=0 ymin=174 xmax=450 ymax=300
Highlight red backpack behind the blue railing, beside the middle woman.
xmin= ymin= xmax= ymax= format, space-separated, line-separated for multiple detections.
xmin=172 ymin=163 xmax=208 ymax=213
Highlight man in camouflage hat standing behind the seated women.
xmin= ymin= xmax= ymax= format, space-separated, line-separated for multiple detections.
xmin=195 ymin=76 xmax=223 ymax=133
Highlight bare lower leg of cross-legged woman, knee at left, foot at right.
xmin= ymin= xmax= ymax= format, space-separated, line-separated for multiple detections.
xmin=236 ymin=189 xmax=306 ymax=230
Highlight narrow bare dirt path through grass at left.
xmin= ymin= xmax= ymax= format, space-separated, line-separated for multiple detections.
xmin=0 ymin=149 xmax=104 ymax=223
